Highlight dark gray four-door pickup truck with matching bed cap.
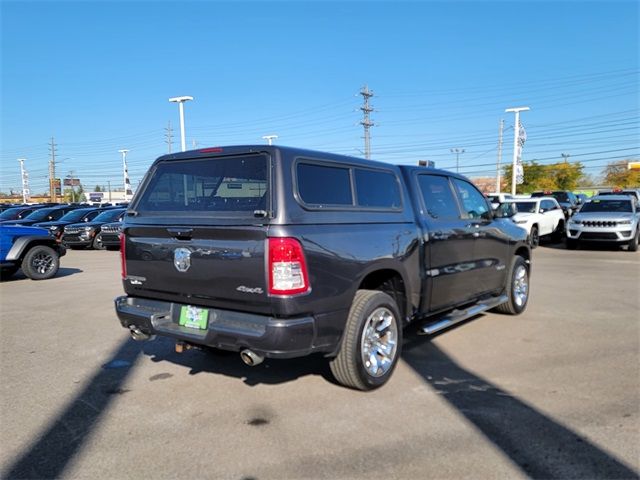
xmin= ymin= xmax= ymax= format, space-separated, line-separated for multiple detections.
xmin=115 ymin=145 xmax=531 ymax=390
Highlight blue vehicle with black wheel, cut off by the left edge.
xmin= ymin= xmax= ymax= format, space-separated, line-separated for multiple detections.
xmin=0 ymin=225 xmax=65 ymax=280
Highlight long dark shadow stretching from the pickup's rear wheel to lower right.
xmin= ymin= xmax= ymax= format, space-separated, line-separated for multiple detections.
xmin=402 ymin=332 xmax=639 ymax=479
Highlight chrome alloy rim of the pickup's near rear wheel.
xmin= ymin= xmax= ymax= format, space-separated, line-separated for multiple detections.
xmin=360 ymin=307 xmax=398 ymax=377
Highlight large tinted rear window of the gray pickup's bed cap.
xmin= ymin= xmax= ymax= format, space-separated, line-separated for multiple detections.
xmin=134 ymin=155 xmax=268 ymax=214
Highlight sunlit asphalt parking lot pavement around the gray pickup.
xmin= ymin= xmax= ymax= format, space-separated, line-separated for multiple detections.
xmin=0 ymin=245 xmax=640 ymax=480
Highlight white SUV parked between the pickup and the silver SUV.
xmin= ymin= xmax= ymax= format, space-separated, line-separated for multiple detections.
xmin=505 ymin=197 xmax=565 ymax=248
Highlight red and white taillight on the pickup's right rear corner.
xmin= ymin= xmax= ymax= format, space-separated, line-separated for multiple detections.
xmin=269 ymin=237 xmax=309 ymax=295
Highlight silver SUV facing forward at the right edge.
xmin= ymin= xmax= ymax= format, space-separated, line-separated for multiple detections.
xmin=567 ymin=195 xmax=640 ymax=252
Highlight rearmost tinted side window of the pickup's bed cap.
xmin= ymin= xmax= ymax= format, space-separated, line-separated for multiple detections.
xmin=297 ymin=163 xmax=353 ymax=205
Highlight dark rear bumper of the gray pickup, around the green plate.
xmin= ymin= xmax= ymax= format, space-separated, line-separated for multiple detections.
xmin=115 ymin=296 xmax=320 ymax=358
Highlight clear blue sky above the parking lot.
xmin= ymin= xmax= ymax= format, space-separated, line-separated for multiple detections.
xmin=0 ymin=0 xmax=640 ymax=192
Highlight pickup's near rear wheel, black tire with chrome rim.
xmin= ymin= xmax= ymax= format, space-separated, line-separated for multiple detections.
xmin=329 ymin=290 xmax=402 ymax=390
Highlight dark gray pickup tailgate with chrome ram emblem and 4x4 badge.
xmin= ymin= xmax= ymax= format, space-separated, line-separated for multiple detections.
xmin=124 ymin=225 xmax=270 ymax=313
